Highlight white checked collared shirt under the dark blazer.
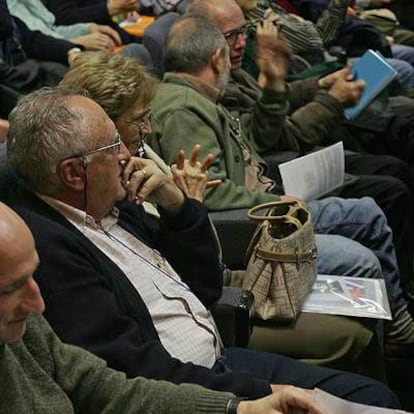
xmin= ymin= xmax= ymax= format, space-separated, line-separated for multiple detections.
xmin=40 ymin=196 xmax=221 ymax=368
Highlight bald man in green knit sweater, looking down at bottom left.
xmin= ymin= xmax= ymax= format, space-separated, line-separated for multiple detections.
xmin=0 ymin=203 xmax=324 ymax=414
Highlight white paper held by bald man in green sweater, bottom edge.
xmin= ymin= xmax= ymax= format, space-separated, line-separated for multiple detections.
xmin=314 ymin=388 xmax=409 ymax=414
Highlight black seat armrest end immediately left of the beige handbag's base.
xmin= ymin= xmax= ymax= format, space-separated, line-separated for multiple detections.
xmin=211 ymin=286 xmax=254 ymax=348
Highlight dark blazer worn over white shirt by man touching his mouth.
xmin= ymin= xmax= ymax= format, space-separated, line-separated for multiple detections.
xmin=15 ymin=190 xmax=271 ymax=398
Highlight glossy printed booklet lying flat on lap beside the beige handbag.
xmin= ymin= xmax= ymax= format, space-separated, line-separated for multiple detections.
xmin=302 ymin=275 xmax=392 ymax=320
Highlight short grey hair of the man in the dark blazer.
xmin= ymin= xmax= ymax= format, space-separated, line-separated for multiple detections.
xmin=9 ymin=88 xmax=95 ymax=194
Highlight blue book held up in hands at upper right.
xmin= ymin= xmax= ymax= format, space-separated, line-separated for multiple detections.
xmin=345 ymin=49 xmax=397 ymax=119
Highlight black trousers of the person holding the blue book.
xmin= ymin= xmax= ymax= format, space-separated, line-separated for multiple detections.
xmin=339 ymin=154 xmax=414 ymax=285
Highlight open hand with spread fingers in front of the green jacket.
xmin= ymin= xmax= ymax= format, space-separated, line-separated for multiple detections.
xmin=171 ymin=144 xmax=221 ymax=202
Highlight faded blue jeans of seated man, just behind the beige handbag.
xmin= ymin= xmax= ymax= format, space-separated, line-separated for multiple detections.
xmin=308 ymin=197 xmax=405 ymax=314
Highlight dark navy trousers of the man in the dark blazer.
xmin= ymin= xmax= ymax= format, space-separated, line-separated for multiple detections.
xmin=218 ymin=348 xmax=399 ymax=408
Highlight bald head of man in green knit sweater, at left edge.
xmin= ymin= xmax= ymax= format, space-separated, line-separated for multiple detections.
xmin=0 ymin=203 xmax=44 ymax=342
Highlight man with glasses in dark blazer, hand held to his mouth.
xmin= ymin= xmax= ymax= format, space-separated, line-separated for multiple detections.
xmin=1 ymin=89 xmax=398 ymax=413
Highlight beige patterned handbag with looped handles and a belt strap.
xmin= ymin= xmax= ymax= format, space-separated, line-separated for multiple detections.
xmin=243 ymin=201 xmax=316 ymax=320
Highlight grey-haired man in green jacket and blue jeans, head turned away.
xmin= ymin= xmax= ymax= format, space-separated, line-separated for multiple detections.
xmin=148 ymin=15 xmax=414 ymax=351
